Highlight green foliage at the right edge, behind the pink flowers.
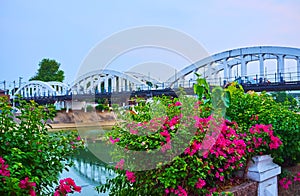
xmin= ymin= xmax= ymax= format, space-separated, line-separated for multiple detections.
xmin=226 ymin=84 xmax=300 ymax=165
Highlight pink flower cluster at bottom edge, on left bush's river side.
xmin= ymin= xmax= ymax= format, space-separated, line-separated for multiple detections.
xmin=54 ymin=178 xmax=81 ymax=196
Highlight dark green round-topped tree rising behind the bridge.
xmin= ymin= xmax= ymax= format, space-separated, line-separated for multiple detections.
xmin=29 ymin=59 xmax=65 ymax=82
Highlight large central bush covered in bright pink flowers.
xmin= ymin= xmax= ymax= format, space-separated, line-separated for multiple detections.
xmin=97 ymin=77 xmax=281 ymax=195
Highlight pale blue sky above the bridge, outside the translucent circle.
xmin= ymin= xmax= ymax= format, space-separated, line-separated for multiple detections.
xmin=0 ymin=0 xmax=300 ymax=88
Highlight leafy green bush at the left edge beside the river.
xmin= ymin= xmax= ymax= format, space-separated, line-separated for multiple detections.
xmin=0 ymin=98 xmax=83 ymax=195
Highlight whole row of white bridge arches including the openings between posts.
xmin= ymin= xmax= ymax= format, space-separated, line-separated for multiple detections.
xmin=15 ymin=46 xmax=300 ymax=98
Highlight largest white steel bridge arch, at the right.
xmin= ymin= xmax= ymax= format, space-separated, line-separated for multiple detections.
xmin=166 ymin=46 xmax=300 ymax=86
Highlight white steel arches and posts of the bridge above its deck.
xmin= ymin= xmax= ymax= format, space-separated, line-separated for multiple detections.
xmin=15 ymin=46 xmax=300 ymax=97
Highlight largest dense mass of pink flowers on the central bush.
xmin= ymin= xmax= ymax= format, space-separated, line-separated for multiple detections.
xmin=184 ymin=116 xmax=246 ymax=175
